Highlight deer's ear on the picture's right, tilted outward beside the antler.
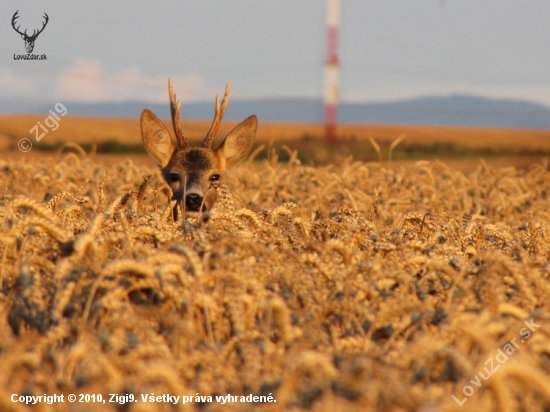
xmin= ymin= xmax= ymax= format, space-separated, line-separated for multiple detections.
xmin=216 ymin=115 xmax=258 ymax=169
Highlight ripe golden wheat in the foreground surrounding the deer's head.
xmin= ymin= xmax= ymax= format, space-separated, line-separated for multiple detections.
xmin=0 ymin=152 xmax=550 ymax=412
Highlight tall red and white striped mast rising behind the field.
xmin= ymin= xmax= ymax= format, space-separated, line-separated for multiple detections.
xmin=325 ymin=0 xmax=340 ymax=143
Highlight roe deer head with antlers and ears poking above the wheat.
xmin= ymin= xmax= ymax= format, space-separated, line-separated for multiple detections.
xmin=141 ymin=79 xmax=258 ymax=216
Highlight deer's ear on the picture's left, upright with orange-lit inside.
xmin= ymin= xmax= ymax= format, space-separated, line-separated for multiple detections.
xmin=141 ymin=109 xmax=176 ymax=168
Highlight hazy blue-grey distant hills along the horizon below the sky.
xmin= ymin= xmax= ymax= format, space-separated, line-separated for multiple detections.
xmin=0 ymin=95 xmax=550 ymax=129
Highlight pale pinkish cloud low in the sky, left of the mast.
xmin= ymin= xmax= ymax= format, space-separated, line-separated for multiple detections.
xmin=55 ymin=59 xmax=215 ymax=103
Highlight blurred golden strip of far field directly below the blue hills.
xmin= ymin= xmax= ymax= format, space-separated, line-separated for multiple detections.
xmin=0 ymin=115 xmax=550 ymax=152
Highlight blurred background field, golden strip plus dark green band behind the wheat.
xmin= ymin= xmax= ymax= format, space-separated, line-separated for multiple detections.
xmin=0 ymin=115 xmax=550 ymax=170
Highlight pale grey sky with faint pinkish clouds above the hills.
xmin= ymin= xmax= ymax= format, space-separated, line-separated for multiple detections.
xmin=0 ymin=0 xmax=550 ymax=106
